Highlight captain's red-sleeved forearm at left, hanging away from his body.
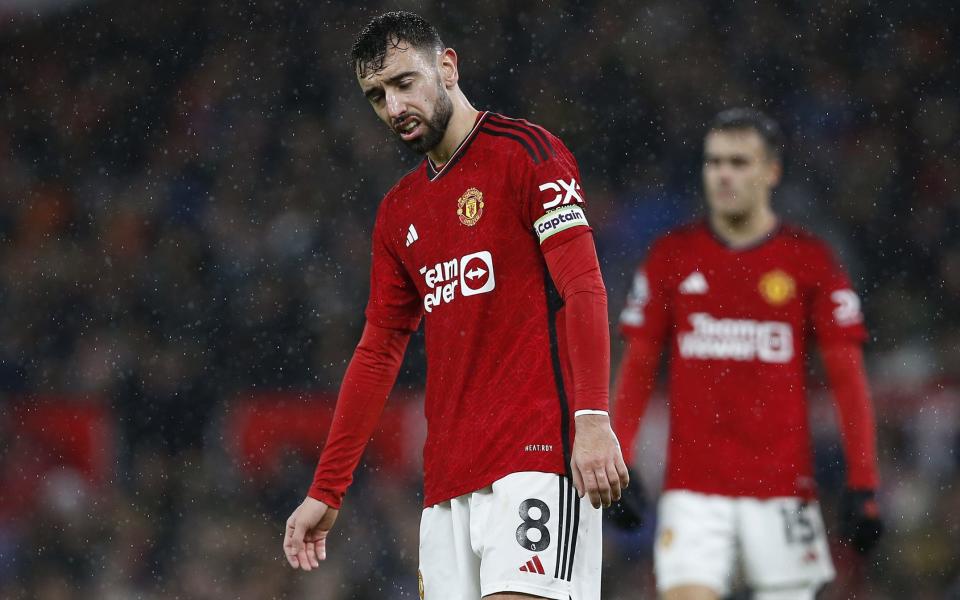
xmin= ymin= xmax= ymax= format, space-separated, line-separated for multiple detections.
xmin=308 ymin=323 xmax=410 ymax=508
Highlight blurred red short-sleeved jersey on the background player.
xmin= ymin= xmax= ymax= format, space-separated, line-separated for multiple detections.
xmin=620 ymin=223 xmax=866 ymax=498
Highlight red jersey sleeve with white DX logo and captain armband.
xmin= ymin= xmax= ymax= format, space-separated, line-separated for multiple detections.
xmin=522 ymin=131 xmax=591 ymax=253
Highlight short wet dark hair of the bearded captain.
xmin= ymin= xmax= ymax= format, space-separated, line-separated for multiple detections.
xmin=350 ymin=10 xmax=444 ymax=77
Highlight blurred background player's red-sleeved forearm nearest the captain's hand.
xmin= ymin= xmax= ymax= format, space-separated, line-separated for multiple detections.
xmin=613 ymin=339 xmax=660 ymax=465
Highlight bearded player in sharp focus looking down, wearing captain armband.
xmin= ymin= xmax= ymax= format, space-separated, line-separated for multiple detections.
xmin=283 ymin=12 xmax=627 ymax=600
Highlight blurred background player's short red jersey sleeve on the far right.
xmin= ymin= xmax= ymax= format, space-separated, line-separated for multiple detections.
xmin=812 ymin=246 xmax=867 ymax=345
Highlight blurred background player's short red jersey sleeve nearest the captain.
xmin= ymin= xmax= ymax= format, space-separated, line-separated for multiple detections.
xmin=620 ymin=240 xmax=670 ymax=342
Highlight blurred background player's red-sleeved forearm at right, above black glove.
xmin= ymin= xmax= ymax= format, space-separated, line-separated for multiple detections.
xmin=822 ymin=344 xmax=879 ymax=489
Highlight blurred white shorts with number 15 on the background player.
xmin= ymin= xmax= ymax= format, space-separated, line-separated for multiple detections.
xmin=654 ymin=490 xmax=835 ymax=598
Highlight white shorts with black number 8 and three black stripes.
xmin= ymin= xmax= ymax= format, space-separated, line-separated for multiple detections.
xmin=420 ymin=472 xmax=602 ymax=600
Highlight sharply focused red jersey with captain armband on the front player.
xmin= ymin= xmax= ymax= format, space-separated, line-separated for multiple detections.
xmin=366 ymin=113 xmax=590 ymax=506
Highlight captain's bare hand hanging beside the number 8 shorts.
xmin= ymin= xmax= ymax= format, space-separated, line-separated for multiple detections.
xmin=570 ymin=415 xmax=630 ymax=508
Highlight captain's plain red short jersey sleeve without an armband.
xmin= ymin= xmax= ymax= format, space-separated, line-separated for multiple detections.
xmin=366 ymin=205 xmax=423 ymax=331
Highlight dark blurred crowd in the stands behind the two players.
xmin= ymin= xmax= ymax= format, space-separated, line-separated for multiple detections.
xmin=0 ymin=0 xmax=960 ymax=600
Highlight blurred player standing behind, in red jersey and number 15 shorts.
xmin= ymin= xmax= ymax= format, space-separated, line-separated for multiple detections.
xmin=614 ymin=109 xmax=881 ymax=600
